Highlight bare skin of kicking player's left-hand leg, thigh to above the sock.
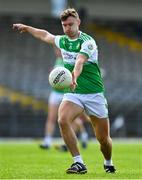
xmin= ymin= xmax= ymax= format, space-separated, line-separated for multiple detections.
xmin=58 ymin=101 xmax=83 ymax=156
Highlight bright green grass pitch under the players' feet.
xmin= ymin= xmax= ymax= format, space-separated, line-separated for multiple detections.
xmin=0 ymin=141 xmax=142 ymax=179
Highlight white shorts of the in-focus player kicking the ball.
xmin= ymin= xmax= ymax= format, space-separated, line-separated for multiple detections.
xmin=62 ymin=93 xmax=108 ymax=118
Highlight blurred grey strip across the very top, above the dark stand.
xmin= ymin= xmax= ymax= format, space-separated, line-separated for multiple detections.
xmin=0 ymin=0 xmax=142 ymax=19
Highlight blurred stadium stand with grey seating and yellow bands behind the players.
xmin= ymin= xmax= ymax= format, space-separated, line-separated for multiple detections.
xmin=0 ymin=0 xmax=142 ymax=138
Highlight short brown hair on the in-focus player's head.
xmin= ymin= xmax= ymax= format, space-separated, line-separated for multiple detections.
xmin=60 ymin=8 xmax=79 ymax=21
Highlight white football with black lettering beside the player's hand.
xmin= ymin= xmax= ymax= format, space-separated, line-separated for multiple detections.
xmin=49 ymin=67 xmax=72 ymax=89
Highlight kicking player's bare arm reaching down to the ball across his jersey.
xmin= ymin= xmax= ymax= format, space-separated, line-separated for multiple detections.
xmin=71 ymin=54 xmax=88 ymax=90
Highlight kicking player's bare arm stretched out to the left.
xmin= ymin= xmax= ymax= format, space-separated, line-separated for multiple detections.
xmin=13 ymin=24 xmax=55 ymax=45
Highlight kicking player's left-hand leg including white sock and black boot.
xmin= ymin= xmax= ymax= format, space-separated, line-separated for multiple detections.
xmin=58 ymin=101 xmax=87 ymax=173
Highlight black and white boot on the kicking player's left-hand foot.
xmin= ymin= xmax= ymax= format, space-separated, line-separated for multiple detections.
xmin=66 ymin=162 xmax=87 ymax=174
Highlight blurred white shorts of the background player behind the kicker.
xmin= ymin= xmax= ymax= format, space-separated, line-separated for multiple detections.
xmin=48 ymin=91 xmax=64 ymax=105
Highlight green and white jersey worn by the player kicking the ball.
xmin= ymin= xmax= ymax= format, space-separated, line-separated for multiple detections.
xmin=55 ymin=31 xmax=104 ymax=94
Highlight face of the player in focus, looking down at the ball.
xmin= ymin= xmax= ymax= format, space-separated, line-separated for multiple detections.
xmin=62 ymin=16 xmax=80 ymax=39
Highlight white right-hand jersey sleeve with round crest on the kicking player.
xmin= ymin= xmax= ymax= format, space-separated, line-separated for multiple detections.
xmin=80 ymin=40 xmax=97 ymax=58
